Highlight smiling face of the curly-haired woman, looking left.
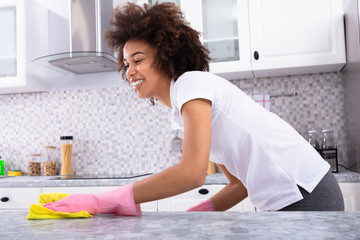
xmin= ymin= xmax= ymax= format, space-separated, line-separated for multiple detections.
xmin=123 ymin=40 xmax=171 ymax=105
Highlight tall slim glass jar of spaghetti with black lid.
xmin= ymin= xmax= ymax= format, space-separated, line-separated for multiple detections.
xmin=60 ymin=136 xmax=73 ymax=177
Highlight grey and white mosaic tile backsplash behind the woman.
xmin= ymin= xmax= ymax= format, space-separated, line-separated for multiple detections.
xmin=0 ymin=73 xmax=347 ymax=176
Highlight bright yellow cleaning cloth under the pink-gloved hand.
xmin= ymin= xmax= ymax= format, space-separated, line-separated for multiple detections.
xmin=26 ymin=193 xmax=93 ymax=219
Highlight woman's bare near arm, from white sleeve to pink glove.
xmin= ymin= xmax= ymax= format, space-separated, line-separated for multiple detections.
xmin=133 ymin=99 xmax=211 ymax=203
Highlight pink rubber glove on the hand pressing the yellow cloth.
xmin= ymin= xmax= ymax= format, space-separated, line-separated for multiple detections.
xmin=42 ymin=183 xmax=141 ymax=216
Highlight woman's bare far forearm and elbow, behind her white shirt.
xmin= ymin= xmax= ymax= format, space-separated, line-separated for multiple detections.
xmin=210 ymin=164 xmax=248 ymax=211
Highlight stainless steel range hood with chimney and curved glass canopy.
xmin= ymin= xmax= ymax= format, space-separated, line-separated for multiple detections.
xmin=33 ymin=0 xmax=117 ymax=74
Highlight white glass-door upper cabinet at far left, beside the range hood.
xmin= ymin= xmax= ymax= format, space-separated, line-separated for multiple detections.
xmin=0 ymin=0 xmax=47 ymax=94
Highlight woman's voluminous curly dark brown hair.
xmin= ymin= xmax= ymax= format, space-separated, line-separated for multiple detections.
xmin=104 ymin=2 xmax=210 ymax=80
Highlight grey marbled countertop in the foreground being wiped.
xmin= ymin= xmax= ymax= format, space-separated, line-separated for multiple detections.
xmin=0 ymin=211 xmax=360 ymax=240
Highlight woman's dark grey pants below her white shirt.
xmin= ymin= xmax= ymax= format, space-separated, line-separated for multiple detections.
xmin=279 ymin=171 xmax=344 ymax=211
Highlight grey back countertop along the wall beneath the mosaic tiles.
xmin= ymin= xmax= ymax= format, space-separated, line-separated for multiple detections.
xmin=0 ymin=169 xmax=360 ymax=187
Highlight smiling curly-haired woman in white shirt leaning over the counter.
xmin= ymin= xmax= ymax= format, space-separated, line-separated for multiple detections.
xmin=44 ymin=3 xmax=344 ymax=215
